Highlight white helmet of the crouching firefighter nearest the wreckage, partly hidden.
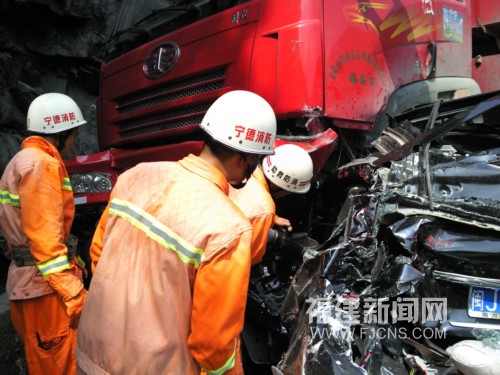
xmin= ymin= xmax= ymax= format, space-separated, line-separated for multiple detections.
xmin=262 ymin=144 xmax=313 ymax=194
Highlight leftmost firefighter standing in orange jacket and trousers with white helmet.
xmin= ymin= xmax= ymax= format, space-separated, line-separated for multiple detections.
xmin=0 ymin=93 xmax=87 ymax=375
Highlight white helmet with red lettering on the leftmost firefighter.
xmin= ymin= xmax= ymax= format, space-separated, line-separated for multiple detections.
xmin=26 ymin=92 xmax=87 ymax=134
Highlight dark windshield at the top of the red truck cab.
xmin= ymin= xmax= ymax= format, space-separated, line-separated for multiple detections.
xmin=104 ymin=0 xmax=249 ymax=61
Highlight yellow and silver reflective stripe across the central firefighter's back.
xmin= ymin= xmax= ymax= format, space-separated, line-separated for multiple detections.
xmin=109 ymin=198 xmax=203 ymax=268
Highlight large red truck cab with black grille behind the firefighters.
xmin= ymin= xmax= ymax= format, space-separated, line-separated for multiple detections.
xmin=66 ymin=0 xmax=480 ymax=206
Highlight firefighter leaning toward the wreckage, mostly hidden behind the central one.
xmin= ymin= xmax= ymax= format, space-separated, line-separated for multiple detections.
xmin=229 ymin=144 xmax=313 ymax=265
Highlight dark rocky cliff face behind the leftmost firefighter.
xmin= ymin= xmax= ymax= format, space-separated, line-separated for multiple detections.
xmin=0 ymin=0 xmax=122 ymax=172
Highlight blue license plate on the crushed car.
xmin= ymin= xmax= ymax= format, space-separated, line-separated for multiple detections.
xmin=468 ymin=286 xmax=500 ymax=319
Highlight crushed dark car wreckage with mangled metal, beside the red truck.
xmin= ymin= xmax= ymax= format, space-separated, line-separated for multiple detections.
xmin=242 ymin=91 xmax=500 ymax=375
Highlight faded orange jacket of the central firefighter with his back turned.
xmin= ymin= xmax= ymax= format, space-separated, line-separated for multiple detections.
xmin=76 ymin=155 xmax=252 ymax=375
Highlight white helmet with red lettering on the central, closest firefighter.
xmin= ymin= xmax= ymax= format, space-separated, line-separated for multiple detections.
xmin=200 ymin=90 xmax=276 ymax=155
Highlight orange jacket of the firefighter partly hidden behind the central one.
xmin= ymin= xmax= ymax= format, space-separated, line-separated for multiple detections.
xmin=229 ymin=166 xmax=276 ymax=265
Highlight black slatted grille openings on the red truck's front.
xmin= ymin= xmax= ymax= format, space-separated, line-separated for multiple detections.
xmin=116 ymin=70 xmax=226 ymax=139
